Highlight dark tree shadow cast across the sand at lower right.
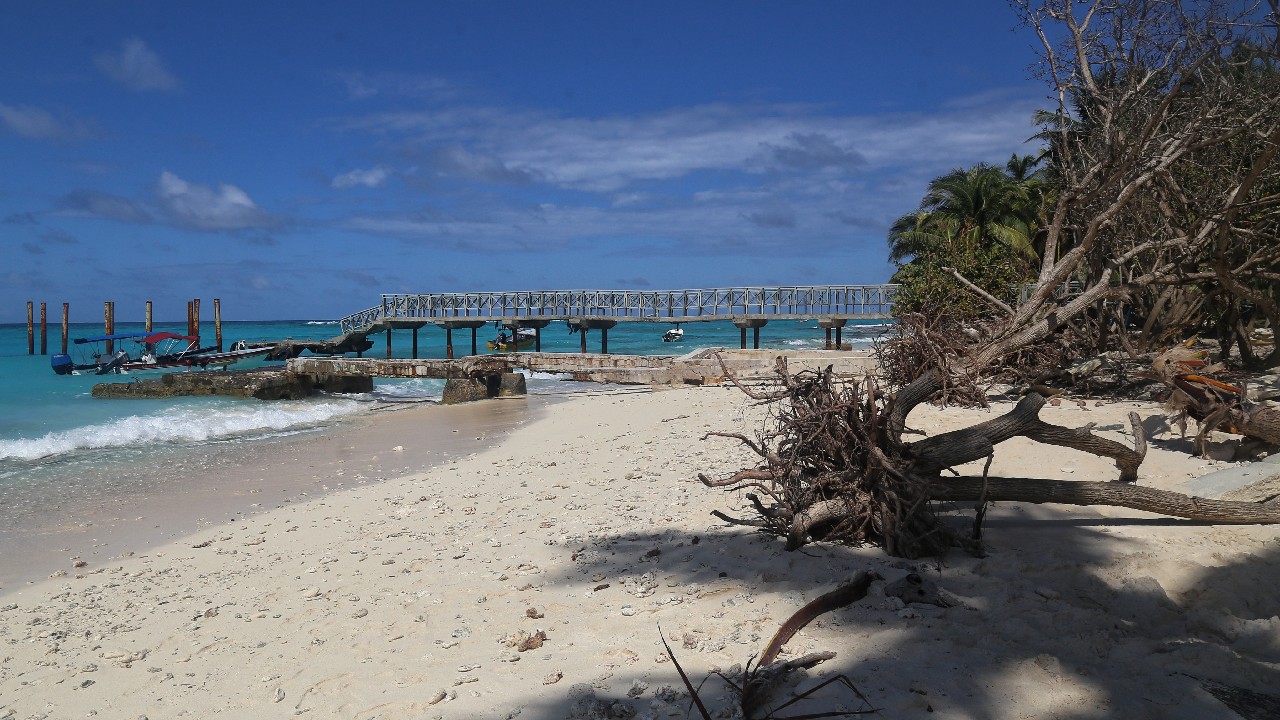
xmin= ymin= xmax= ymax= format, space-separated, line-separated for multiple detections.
xmin=504 ymin=506 xmax=1280 ymax=720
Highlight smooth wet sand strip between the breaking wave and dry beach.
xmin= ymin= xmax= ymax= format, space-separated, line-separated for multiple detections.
xmin=0 ymin=396 xmax=545 ymax=593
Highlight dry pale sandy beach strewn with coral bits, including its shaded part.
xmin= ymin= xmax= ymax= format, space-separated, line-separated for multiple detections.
xmin=0 ymin=386 xmax=1280 ymax=720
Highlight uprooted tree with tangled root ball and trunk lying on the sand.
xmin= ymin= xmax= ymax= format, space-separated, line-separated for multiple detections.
xmin=699 ymin=357 xmax=1280 ymax=557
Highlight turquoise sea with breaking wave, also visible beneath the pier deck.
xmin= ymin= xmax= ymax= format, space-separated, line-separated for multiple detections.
xmin=0 ymin=313 xmax=883 ymax=512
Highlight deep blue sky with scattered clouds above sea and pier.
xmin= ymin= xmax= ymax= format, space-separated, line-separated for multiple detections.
xmin=0 ymin=0 xmax=1048 ymax=322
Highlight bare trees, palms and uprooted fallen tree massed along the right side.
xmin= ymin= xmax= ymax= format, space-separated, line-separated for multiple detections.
xmin=703 ymin=0 xmax=1280 ymax=557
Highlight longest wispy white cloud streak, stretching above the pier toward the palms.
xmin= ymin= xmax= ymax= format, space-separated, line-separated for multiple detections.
xmin=344 ymin=92 xmax=1037 ymax=192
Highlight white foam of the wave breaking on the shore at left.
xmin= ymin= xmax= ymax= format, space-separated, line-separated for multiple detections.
xmin=0 ymin=400 xmax=362 ymax=460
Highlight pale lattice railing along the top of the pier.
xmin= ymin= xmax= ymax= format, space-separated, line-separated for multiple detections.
xmin=340 ymin=284 xmax=897 ymax=333
